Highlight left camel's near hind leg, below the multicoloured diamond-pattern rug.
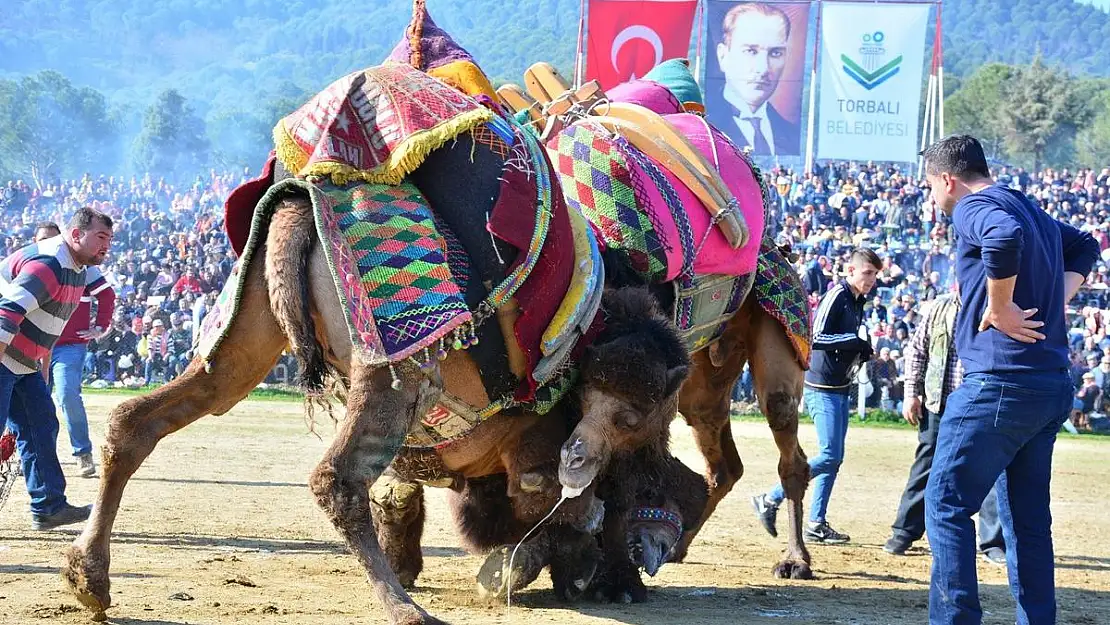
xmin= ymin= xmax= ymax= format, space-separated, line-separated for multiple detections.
xmin=309 ymin=359 xmax=443 ymax=625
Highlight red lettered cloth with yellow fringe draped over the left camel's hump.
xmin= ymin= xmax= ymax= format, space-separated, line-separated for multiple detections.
xmin=273 ymin=63 xmax=494 ymax=184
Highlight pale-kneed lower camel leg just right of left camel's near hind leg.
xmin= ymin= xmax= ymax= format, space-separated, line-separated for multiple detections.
xmin=370 ymin=468 xmax=424 ymax=588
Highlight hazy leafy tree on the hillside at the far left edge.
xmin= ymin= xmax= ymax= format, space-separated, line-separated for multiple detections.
xmin=0 ymin=71 xmax=118 ymax=187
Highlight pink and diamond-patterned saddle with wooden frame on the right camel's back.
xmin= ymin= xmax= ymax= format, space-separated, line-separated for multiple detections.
xmin=497 ymin=59 xmax=809 ymax=366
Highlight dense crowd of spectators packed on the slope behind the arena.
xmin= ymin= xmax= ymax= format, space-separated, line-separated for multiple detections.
xmin=0 ymin=162 xmax=1110 ymax=425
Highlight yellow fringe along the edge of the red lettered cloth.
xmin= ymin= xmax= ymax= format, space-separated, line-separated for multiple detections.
xmin=273 ymin=108 xmax=494 ymax=184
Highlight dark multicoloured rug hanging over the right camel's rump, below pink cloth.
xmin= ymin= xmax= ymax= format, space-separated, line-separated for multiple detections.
xmin=751 ymin=239 xmax=811 ymax=369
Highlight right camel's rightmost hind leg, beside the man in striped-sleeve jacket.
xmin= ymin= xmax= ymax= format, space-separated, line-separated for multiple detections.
xmin=747 ymin=309 xmax=814 ymax=579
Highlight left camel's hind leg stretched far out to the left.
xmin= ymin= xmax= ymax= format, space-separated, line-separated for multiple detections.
xmin=62 ymin=256 xmax=285 ymax=617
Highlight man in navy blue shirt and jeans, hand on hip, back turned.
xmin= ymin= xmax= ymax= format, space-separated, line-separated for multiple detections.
xmin=922 ymin=135 xmax=1099 ymax=625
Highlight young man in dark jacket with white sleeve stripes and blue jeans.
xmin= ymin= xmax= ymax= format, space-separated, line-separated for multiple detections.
xmin=751 ymin=248 xmax=882 ymax=544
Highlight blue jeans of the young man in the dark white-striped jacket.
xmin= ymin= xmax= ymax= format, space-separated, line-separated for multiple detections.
xmin=767 ymin=386 xmax=850 ymax=523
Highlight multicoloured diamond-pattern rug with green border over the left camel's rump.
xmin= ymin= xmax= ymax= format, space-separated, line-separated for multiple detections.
xmin=198 ymin=179 xmax=473 ymax=366
